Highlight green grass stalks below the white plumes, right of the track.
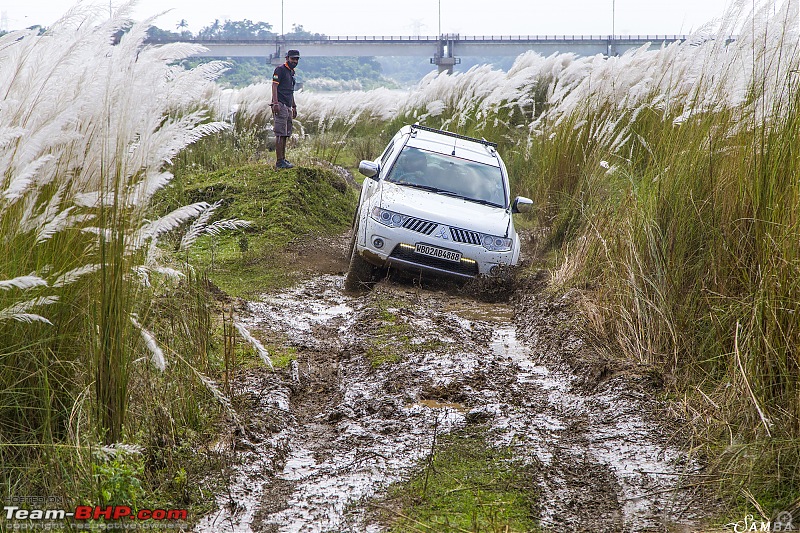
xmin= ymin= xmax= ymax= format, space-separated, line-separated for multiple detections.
xmin=510 ymin=56 xmax=800 ymax=516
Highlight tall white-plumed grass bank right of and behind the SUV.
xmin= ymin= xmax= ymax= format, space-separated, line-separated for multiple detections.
xmin=223 ymin=0 xmax=800 ymax=506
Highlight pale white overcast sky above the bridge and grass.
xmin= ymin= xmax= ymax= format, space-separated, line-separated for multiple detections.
xmin=0 ymin=0 xmax=731 ymax=36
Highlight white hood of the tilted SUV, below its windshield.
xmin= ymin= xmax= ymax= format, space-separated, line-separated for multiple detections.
xmin=380 ymin=180 xmax=511 ymax=237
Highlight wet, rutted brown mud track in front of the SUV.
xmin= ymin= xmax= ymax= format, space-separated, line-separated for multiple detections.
xmin=197 ymin=239 xmax=702 ymax=532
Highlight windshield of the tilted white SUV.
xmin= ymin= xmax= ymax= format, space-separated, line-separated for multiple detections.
xmin=386 ymin=146 xmax=506 ymax=208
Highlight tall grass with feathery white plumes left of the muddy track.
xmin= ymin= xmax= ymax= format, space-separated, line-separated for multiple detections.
xmin=0 ymin=1 xmax=234 ymax=496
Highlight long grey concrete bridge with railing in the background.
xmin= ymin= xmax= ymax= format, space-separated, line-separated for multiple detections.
xmin=158 ymin=34 xmax=687 ymax=72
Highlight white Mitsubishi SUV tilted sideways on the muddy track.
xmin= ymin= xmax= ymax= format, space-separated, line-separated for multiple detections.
xmin=345 ymin=124 xmax=533 ymax=290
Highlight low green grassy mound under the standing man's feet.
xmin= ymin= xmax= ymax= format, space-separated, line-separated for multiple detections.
xmin=177 ymin=163 xmax=358 ymax=297
